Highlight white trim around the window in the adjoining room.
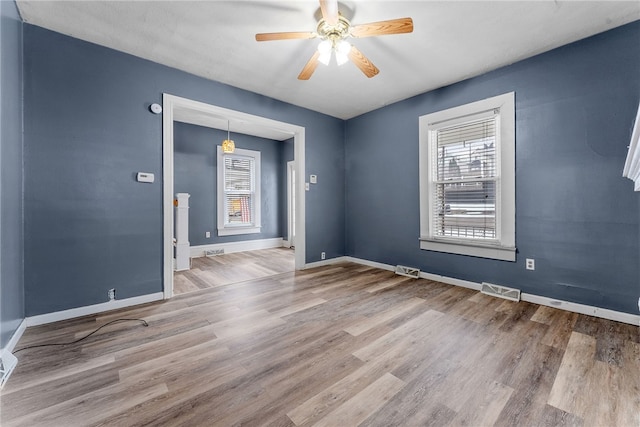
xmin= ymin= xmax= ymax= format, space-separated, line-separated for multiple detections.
xmin=216 ymin=145 xmax=262 ymax=236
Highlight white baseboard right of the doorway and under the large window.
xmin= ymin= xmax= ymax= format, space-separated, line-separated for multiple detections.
xmin=336 ymin=256 xmax=640 ymax=326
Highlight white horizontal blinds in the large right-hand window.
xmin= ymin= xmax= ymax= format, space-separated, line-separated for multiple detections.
xmin=431 ymin=115 xmax=498 ymax=241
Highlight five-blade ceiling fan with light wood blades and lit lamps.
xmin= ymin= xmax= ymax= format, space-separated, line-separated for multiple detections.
xmin=256 ymin=0 xmax=413 ymax=80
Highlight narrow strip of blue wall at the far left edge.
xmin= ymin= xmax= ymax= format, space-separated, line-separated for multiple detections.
xmin=0 ymin=1 xmax=25 ymax=349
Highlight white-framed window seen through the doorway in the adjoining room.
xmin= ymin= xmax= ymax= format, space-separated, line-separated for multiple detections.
xmin=217 ymin=146 xmax=260 ymax=236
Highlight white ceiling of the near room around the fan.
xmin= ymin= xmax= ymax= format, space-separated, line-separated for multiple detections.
xmin=17 ymin=0 xmax=640 ymax=119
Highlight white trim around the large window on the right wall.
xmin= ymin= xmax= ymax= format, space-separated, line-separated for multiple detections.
xmin=419 ymin=92 xmax=516 ymax=261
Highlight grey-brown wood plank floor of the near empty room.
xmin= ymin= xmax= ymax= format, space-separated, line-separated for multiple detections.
xmin=0 ymin=263 xmax=640 ymax=427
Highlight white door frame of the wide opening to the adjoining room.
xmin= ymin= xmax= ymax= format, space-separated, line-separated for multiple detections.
xmin=162 ymin=93 xmax=306 ymax=299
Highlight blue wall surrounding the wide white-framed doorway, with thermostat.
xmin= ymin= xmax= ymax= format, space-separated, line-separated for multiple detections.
xmin=24 ymin=24 xmax=344 ymax=316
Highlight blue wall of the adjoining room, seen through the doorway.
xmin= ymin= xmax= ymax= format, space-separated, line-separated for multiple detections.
xmin=173 ymin=123 xmax=293 ymax=246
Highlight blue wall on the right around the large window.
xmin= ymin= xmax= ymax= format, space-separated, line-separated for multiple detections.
xmin=346 ymin=22 xmax=640 ymax=313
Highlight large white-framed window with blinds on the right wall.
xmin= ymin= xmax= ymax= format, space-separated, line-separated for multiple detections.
xmin=420 ymin=92 xmax=515 ymax=261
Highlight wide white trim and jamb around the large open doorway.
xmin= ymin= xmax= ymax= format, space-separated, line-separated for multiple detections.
xmin=162 ymin=93 xmax=306 ymax=299
